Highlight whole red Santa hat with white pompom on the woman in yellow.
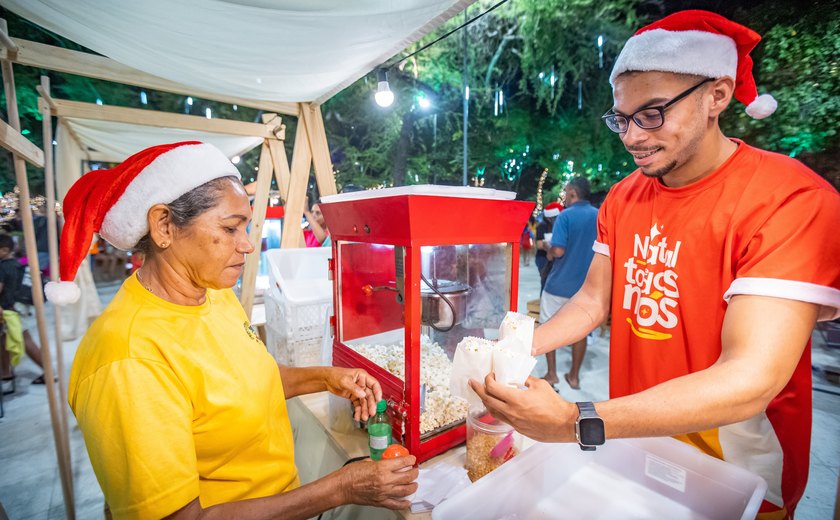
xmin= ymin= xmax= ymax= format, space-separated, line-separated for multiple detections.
xmin=44 ymin=141 xmax=239 ymax=305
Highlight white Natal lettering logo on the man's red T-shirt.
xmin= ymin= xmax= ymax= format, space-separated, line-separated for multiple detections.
xmin=622 ymin=224 xmax=682 ymax=340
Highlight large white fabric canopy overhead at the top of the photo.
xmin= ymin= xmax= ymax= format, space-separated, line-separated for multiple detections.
xmin=0 ymin=0 xmax=474 ymax=103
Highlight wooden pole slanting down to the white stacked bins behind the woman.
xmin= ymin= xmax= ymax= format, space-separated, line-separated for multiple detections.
xmin=280 ymin=103 xmax=312 ymax=248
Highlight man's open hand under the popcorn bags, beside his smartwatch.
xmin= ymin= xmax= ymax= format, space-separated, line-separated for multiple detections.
xmin=470 ymin=372 xmax=577 ymax=442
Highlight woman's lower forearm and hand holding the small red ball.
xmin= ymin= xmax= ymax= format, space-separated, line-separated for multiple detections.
xmin=167 ymin=456 xmax=418 ymax=520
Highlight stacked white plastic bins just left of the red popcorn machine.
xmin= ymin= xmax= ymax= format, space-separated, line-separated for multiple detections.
xmin=265 ymin=248 xmax=332 ymax=366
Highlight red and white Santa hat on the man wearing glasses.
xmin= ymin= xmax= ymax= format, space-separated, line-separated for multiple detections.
xmin=610 ymin=10 xmax=777 ymax=119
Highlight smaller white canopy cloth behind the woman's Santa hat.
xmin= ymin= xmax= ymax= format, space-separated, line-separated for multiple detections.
xmin=62 ymin=117 xmax=263 ymax=162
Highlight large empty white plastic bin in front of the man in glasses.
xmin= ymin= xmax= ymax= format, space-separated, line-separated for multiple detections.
xmin=432 ymin=438 xmax=767 ymax=520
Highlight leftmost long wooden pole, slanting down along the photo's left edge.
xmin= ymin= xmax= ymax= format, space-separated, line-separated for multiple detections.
xmin=0 ymin=37 xmax=76 ymax=520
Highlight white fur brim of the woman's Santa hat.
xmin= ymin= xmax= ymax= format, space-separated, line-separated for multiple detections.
xmin=99 ymin=143 xmax=240 ymax=251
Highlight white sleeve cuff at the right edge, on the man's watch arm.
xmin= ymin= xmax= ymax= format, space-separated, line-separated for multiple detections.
xmin=720 ymin=276 xmax=840 ymax=321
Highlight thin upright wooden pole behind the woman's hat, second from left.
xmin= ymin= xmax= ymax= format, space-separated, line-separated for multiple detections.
xmin=38 ymin=76 xmax=70 ymax=476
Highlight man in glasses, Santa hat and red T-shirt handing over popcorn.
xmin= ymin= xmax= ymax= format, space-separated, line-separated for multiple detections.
xmin=473 ymin=11 xmax=840 ymax=518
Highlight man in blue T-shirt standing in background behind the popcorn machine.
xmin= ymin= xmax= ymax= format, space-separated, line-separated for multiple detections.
xmin=540 ymin=177 xmax=598 ymax=390
